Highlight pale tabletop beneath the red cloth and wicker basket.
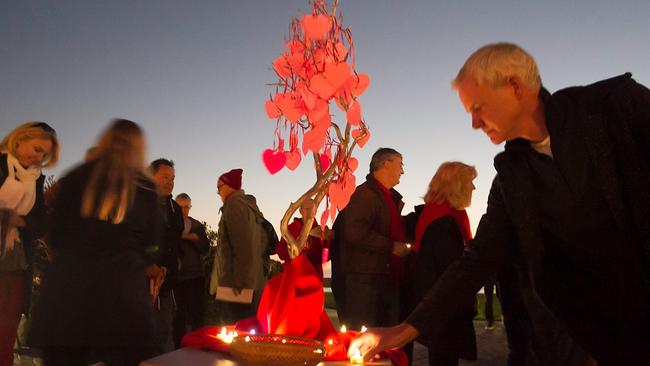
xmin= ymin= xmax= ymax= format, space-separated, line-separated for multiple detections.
xmin=140 ymin=348 xmax=392 ymax=366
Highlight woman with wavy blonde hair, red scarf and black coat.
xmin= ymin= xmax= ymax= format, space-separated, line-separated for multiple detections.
xmin=406 ymin=162 xmax=476 ymax=366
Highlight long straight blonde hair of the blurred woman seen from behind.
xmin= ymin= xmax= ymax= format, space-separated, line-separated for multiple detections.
xmin=81 ymin=119 xmax=145 ymax=224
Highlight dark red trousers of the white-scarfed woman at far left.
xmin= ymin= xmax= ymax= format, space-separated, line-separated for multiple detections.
xmin=0 ymin=272 xmax=25 ymax=366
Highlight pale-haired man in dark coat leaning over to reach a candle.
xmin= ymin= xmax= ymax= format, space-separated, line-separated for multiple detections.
xmin=350 ymin=43 xmax=650 ymax=366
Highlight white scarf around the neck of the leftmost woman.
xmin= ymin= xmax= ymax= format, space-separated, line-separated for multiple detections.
xmin=0 ymin=153 xmax=41 ymax=256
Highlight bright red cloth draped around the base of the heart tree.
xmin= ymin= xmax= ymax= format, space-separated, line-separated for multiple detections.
xmin=181 ymin=253 xmax=408 ymax=366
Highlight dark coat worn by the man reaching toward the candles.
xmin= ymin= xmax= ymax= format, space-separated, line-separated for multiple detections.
xmin=407 ymin=74 xmax=650 ymax=364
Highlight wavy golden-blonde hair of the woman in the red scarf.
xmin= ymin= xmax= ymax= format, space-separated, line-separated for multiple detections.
xmin=424 ymin=161 xmax=477 ymax=210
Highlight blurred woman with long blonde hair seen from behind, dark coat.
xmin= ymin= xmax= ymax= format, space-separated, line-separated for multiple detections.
xmin=32 ymin=120 xmax=158 ymax=366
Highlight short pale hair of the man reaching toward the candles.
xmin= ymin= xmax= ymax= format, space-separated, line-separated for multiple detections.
xmin=451 ymin=42 xmax=542 ymax=89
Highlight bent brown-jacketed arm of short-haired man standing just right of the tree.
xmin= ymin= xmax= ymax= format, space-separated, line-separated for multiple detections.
xmin=342 ymin=189 xmax=393 ymax=253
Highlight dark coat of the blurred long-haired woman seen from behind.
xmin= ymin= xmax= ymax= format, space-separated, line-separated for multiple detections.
xmin=31 ymin=162 xmax=160 ymax=348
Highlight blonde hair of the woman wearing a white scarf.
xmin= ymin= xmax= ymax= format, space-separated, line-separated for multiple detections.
xmin=0 ymin=121 xmax=59 ymax=168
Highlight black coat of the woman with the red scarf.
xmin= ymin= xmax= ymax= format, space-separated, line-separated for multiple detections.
xmin=403 ymin=212 xmax=476 ymax=360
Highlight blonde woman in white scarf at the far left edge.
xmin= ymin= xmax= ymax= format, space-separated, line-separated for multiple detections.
xmin=0 ymin=122 xmax=59 ymax=366
